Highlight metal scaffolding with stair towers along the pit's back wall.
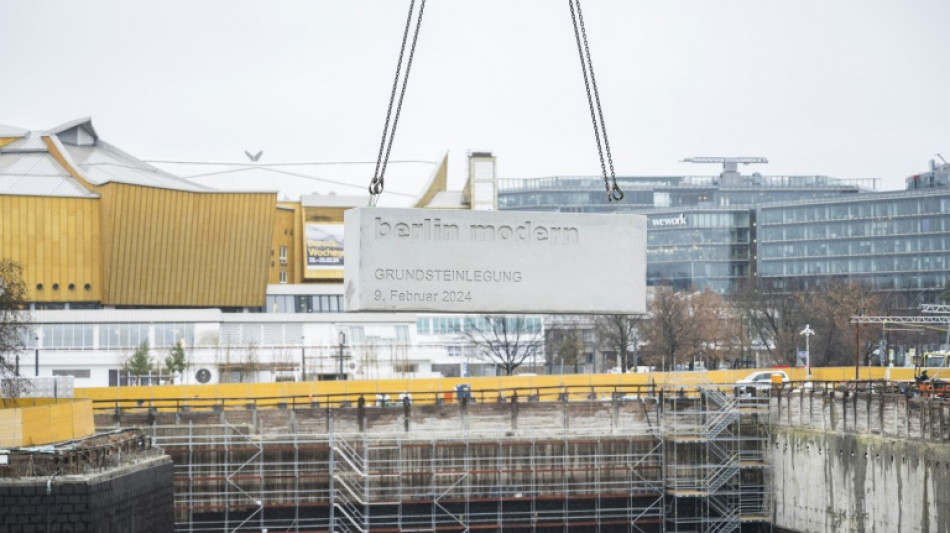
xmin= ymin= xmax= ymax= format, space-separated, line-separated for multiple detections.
xmin=151 ymin=387 xmax=771 ymax=533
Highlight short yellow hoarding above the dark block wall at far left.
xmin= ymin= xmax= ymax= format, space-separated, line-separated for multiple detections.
xmin=0 ymin=398 xmax=95 ymax=448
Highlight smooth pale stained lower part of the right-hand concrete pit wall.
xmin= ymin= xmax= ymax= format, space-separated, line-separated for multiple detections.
xmin=772 ymin=428 xmax=950 ymax=533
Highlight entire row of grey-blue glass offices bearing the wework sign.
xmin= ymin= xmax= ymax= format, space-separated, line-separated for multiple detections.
xmin=498 ymin=158 xmax=950 ymax=302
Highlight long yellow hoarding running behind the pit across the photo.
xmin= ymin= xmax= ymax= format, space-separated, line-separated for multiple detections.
xmin=75 ymin=367 xmax=913 ymax=408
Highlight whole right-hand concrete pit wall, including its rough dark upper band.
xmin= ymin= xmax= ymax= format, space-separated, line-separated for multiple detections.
xmin=771 ymin=390 xmax=950 ymax=533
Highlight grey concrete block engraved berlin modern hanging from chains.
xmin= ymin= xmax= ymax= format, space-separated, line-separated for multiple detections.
xmin=344 ymin=208 xmax=646 ymax=314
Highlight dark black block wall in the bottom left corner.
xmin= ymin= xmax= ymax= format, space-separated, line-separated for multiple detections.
xmin=0 ymin=457 xmax=174 ymax=533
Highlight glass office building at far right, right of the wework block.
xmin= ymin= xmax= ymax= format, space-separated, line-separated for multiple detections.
xmin=756 ymin=188 xmax=950 ymax=301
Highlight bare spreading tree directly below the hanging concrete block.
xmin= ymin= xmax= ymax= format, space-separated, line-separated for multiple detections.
xmin=462 ymin=315 xmax=544 ymax=376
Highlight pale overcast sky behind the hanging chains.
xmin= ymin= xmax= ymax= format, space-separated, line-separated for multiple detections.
xmin=0 ymin=0 xmax=950 ymax=189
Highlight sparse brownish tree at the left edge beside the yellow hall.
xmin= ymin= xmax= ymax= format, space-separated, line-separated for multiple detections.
xmin=0 ymin=260 xmax=33 ymax=398
